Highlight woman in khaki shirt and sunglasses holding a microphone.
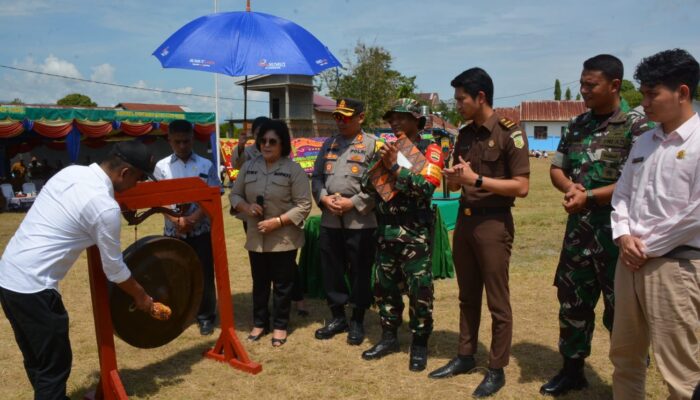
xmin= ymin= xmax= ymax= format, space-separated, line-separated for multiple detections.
xmin=230 ymin=121 xmax=311 ymax=346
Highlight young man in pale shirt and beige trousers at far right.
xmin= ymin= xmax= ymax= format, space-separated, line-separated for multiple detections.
xmin=610 ymin=49 xmax=700 ymax=399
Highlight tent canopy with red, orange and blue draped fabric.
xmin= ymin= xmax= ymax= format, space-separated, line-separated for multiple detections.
xmin=0 ymin=105 xmax=216 ymax=177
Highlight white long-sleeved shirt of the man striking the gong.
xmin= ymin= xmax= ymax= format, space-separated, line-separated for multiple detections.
xmin=0 ymin=164 xmax=131 ymax=293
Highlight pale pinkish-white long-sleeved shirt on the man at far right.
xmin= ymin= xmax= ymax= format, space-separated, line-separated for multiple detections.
xmin=612 ymin=114 xmax=700 ymax=257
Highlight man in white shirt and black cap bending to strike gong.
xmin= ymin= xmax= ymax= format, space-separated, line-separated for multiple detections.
xmin=0 ymin=141 xmax=153 ymax=399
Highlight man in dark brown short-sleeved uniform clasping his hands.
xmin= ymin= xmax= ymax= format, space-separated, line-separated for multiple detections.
xmin=429 ymin=68 xmax=530 ymax=398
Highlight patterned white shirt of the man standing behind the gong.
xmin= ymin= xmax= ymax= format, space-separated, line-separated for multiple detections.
xmin=153 ymin=153 xmax=221 ymax=237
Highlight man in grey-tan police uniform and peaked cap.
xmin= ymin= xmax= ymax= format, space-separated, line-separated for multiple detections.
xmin=311 ymin=99 xmax=377 ymax=346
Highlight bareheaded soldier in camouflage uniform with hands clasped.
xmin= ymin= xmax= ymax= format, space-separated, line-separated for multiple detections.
xmin=540 ymin=54 xmax=648 ymax=396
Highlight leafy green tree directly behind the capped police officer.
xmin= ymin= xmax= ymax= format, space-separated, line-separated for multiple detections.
xmin=316 ymin=42 xmax=416 ymax=127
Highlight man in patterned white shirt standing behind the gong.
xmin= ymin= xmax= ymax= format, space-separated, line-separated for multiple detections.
xmin=153 ymin=119 xmax=223 ymax=336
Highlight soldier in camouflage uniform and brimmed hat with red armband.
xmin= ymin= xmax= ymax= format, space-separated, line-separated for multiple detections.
xmin=362 ymin=99 xmax=435 ymax=371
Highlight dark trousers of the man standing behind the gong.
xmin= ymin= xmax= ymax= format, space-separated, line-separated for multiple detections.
xmin=182 ymin=232 xmax=216 ymax=323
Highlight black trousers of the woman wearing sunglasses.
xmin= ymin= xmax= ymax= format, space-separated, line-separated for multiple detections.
xmin=248 ymin=250 xmax=297 ymax=330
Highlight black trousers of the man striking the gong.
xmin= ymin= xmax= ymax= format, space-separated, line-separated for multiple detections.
xmin=0 ymin=288 xmax=73 ymax=400
